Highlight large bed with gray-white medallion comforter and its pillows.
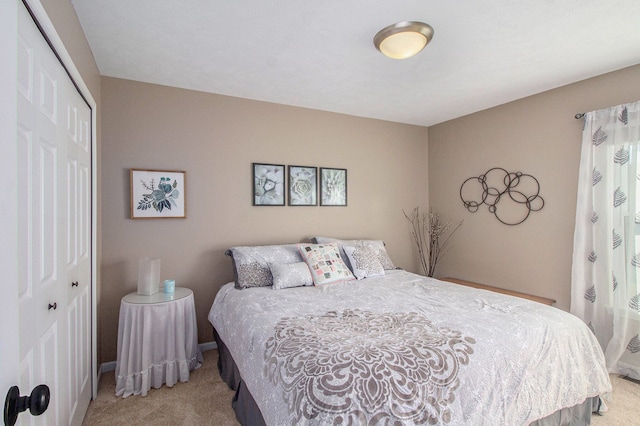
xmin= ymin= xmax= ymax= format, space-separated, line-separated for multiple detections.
xmin=209 ymin=238 xmax=611 ymax=426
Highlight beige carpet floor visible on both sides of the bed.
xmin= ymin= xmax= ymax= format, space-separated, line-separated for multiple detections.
xmin=83 ymin=350 xmax=640 ymax=426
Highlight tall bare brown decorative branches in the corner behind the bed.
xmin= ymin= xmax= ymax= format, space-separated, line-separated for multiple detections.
xmin=402 ymin=207 xmax=462 ymax=277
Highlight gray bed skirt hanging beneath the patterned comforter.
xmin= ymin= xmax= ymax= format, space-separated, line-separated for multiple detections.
xmin=213 ymin=328 xmax=600 ymax=426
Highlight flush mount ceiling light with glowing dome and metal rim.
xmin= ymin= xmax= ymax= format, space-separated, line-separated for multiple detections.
xmin=373 ymin=21 xmax=433 ymax=59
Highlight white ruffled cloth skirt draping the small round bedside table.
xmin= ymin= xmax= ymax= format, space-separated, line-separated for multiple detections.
xmin=116 ymin=288 xmax=202 ymax=398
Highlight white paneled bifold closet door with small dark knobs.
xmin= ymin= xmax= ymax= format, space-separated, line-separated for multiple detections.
xmin=17 ymin=2 xmax=91 ymax=425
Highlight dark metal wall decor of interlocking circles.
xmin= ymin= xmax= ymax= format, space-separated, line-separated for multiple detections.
xmin=460 ymin=167 xmax=544 ymax=225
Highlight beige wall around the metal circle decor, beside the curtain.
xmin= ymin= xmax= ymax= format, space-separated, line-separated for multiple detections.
xmin=429 ymin=66 xmax=640 ymax=310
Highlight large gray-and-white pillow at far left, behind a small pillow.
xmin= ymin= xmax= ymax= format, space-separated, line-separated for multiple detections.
xmin=225 ymin=244 xmax=302 ymax=289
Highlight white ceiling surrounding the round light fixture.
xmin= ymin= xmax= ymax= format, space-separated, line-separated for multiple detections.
xmin=71 ymin=0 xmax=640 ymax=126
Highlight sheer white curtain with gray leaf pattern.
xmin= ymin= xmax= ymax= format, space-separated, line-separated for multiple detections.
xmin=571 ymin=101 xmax=640 ymax=379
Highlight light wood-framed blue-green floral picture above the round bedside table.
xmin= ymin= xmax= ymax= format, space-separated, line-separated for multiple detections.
xmin=129 ymin=169 xmax=187 ymax=219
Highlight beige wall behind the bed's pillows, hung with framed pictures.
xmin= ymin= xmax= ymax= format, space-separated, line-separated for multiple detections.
xmin=100 ymin=77 xmax=427 ymax=361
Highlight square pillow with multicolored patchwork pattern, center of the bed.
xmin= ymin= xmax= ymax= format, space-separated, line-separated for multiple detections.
xmin=298 ymin=244 xmax=354 ymax=285
